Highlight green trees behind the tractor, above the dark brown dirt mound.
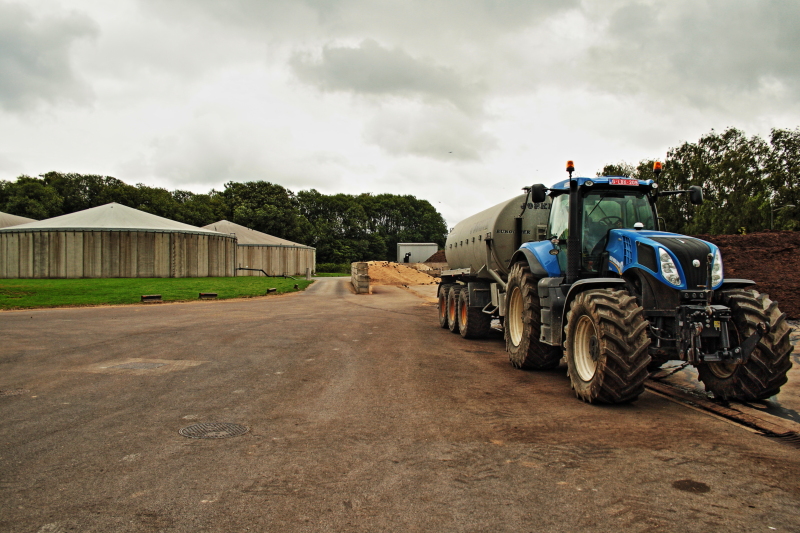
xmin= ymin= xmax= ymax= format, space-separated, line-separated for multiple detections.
xmin=598 ymin=128 xmax=800 ymax=235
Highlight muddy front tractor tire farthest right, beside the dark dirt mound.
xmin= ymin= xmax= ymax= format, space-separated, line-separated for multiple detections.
xmin=697 ymin=289 xmax=792 ymax=401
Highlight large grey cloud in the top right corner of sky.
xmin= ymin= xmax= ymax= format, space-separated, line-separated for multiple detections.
xmin=580 ymin=0 xmax=800 ymax=107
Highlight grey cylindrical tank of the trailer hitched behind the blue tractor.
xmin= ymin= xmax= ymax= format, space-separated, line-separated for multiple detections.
xmin=445 ymin=194 xmax=550 ymax=279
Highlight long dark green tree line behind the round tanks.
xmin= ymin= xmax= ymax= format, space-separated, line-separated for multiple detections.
xmin=0 ymin=172 xmax=447 ymax=263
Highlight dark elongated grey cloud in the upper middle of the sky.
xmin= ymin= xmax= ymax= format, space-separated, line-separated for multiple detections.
xmin=291 ymin=39 xmax=482 ymax=111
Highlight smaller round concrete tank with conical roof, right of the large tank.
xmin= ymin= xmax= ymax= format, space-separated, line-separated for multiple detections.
xmin=203 ymin=220 xmax=317 ymax=276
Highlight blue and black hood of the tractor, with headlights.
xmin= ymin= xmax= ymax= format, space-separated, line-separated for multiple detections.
xmin=606 ymin=229 xmax=722 ymax=289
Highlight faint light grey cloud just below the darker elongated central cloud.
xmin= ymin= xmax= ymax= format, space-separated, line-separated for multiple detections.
xmin=364 ymin=107 xmax=497 ymax=161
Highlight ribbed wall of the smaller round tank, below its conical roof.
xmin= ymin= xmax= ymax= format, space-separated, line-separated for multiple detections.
xmin=236 ymin=244 xmax=317 ymax=276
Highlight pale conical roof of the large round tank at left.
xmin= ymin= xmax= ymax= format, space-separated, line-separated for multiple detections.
xmin=0 ymin=202 xmax=228 ymax=235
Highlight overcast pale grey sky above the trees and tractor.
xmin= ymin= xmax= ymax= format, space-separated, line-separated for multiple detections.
xmin=0 ymin=0 xmax=800 ymax=226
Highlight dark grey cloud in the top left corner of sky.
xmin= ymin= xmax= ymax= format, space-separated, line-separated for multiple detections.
xmin=0 ymin=2 xmax=98 ymax=112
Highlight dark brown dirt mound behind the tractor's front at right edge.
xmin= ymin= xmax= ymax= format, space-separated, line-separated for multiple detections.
xmin=695 ymin=231 xmax=800 ymax=319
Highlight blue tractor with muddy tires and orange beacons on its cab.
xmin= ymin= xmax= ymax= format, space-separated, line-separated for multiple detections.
xmin=466 ymin=162 xmax=791 ymax=403
